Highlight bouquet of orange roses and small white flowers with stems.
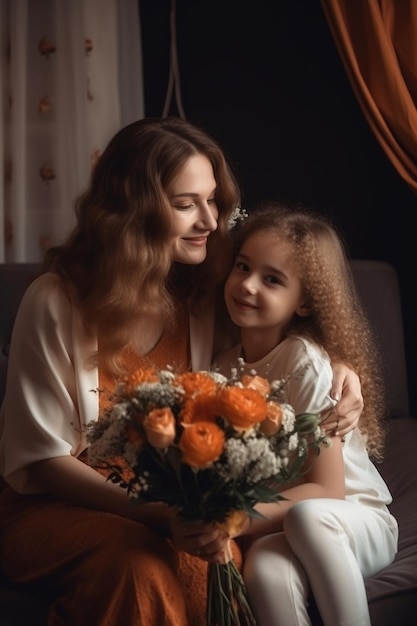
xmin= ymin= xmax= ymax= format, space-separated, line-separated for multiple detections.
xmin=88 ymin=368 xmax=328 ymax=626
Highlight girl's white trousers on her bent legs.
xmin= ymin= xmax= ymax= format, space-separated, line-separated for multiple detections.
xmin=244 ymin=499 xmax=398 ymax=626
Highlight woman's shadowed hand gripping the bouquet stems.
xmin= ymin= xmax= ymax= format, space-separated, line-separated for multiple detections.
xmin=170 ymin=514 xmax=229 ymax=563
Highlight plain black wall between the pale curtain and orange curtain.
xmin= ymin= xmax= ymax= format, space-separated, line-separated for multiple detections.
xmin=139 ymin=0 xmax=417 ymax=414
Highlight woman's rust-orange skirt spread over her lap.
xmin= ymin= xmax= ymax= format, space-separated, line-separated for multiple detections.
xmin=0 ymin=488 xmax=242 ymax=626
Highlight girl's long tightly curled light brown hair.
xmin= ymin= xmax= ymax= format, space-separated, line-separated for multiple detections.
xmin=231 ymin=202 xmax=385 ymax=459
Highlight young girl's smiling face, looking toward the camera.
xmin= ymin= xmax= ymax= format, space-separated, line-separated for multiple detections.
xmin=225 ymin=231 xmax=308 ymax=336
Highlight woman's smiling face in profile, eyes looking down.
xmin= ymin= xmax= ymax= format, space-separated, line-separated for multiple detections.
xmin=167 ymin=154 xmax=219 ymax=264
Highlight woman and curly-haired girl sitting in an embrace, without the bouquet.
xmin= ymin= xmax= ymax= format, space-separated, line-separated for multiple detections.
xmin=0 ymin=118 xmax=396 ymax=626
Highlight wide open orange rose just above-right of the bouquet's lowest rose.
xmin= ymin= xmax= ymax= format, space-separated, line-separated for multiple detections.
xmin=216 ymin=387 xmax=267 ymax=430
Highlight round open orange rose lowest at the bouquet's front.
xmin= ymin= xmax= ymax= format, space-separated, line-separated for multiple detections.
xmin=179 ymin=422 xmax=225 ymax=469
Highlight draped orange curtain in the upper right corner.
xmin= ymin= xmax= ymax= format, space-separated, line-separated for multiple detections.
xmin=321 ymin=0 xmax=417 ymax=193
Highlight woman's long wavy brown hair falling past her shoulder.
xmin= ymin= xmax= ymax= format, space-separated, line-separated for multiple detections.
xmin=44 ymin=118 xmax=240 ymax=372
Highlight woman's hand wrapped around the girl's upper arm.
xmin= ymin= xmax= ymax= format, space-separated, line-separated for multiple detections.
xmin=323 ymin=363 xmax=363 ymax=437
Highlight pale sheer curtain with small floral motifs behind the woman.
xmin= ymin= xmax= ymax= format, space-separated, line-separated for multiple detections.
xmin=0 ymin=0 xmax=144 ymax=262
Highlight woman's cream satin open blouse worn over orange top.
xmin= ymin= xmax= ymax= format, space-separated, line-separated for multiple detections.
xmin=0 ymin=273 xmax=214 ymax=493
